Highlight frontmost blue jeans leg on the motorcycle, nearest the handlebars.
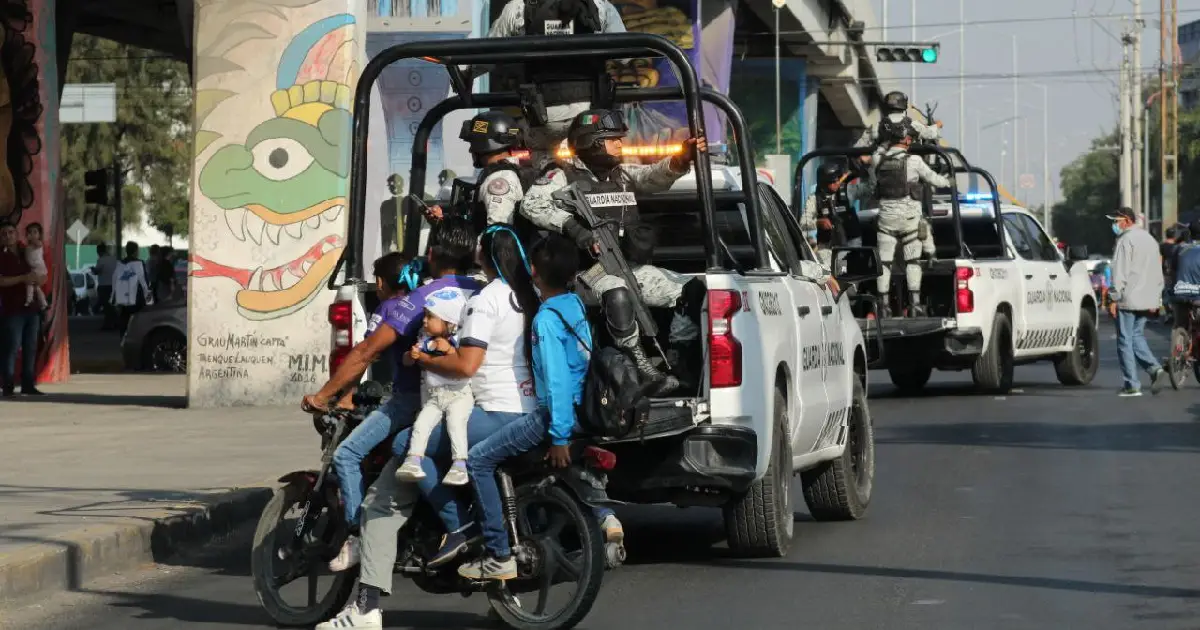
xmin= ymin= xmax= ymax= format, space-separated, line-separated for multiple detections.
xmin=334 ymin=391 xmax=421 ymax=529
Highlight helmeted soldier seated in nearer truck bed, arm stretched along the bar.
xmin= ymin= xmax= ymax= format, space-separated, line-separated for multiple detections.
xmin=521 ymin=109 xmax=708 ymax=394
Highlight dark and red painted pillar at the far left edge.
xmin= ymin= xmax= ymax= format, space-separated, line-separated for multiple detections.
xmin=0 ymin=0 xmax=64 ymax=383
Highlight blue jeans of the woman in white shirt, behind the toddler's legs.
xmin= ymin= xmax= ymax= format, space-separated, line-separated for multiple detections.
xmin=391 ymin=407 xmax=524 ymax=532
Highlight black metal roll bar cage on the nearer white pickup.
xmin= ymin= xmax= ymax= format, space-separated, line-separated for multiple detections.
xmin=329 ymin=32 xmax=766 ymax=282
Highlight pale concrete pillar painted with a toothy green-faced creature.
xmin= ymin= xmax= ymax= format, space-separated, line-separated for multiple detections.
xmin=188 ymin=0 xmax=366 ymax=407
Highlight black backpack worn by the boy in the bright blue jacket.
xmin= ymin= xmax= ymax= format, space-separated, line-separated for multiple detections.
xmin=550 ymin=308 xmax=650 ymax=438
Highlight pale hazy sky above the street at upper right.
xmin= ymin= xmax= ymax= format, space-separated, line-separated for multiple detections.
xmin=864 ymin=0 xmax=1200 ymax=210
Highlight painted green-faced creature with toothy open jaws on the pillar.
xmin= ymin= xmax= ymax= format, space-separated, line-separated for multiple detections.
xmin=192 ymin=2 xmax=359 ymax=320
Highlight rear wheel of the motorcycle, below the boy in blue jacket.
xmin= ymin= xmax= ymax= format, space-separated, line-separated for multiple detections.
xmin=487 ymin=486 xmax=605 ymax=630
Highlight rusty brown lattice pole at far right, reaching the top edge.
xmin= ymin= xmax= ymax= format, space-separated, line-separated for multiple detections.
xmin=1158 ymin=0 xmax=1180 ymax=229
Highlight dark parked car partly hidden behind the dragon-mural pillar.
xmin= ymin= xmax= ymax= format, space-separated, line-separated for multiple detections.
xmin=121 ymin=299 xmax=187 ymax=374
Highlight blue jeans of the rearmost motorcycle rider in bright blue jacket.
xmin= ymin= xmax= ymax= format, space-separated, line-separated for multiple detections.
xmin=467 ymin=409 xmax=550 ymax=558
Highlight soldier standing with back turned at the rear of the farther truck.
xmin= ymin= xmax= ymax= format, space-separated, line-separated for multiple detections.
xmin=871 ymin=115 xmax=950 ymax=317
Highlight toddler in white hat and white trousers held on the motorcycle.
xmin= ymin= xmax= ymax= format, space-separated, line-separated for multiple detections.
xmin=396 ymin=288 xmax=475 ymax=486
